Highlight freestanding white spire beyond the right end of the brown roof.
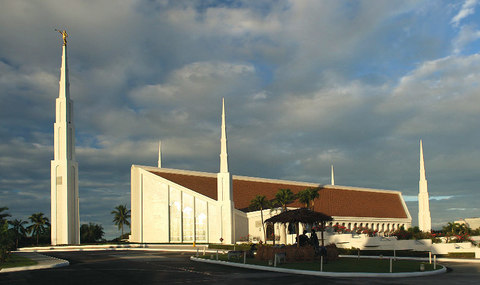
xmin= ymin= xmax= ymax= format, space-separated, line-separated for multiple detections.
xmin=418 ymin=140 xmax=432 ymax=232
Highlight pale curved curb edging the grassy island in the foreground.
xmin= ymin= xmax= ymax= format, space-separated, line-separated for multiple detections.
xmin=190 ymin=256 xmax=447 ymax=278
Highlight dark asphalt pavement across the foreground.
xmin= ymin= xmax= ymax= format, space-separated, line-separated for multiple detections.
xmin=0 ymin=251 xmax=480 ymax=285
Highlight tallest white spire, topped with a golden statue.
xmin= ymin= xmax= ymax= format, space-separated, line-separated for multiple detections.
xmin=51 ymin=31 xmax=80 ymax=245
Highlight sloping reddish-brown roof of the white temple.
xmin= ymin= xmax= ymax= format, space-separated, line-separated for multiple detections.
xmin=146 ymin=165 xmax=408 ymax=219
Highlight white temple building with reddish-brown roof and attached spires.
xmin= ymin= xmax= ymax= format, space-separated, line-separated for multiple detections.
xmin=130 ymin=98 xmax=412 ymax=244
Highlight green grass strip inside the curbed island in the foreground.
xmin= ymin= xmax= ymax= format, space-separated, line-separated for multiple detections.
xmin=199 ymin=254 xmax=441 ymax=273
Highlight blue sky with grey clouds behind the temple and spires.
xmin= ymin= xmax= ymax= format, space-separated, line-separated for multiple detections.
xmin=0 ymin=0 xmax=480 ymax=238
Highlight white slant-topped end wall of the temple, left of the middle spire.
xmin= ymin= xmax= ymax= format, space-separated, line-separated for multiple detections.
xmin=130 ymin=165 xmax=222 ymax=243
